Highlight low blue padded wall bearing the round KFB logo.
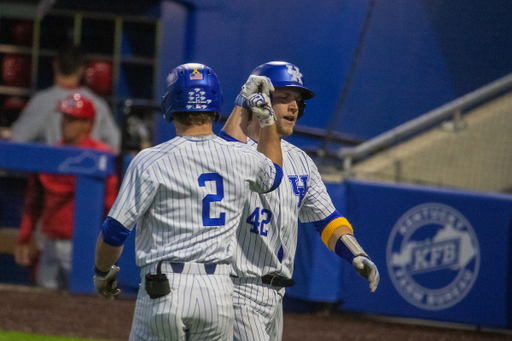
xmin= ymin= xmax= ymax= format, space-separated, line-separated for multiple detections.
xmin=287 ymin=182 xmax=512 ymax=328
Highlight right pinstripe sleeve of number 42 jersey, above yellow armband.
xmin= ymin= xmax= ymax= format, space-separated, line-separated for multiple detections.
xmin=299 ymin=159 xmax=336 ymax=223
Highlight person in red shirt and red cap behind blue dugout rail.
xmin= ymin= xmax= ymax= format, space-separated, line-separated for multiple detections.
xmin=14 ymin=93 xmax=118 ymax=290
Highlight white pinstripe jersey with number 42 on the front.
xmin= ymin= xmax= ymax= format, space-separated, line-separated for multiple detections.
xmin=234 ymin=138 xmax=335 ymax=278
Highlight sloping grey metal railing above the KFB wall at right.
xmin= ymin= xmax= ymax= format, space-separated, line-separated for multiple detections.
xmin=337 ymin=73 xmax=512 ymax=176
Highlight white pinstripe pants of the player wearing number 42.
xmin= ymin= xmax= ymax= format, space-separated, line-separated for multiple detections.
xmin=233 ymin=278 xmax=285 ymax=341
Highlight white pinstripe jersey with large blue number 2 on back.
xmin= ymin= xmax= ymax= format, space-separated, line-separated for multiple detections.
xmin=109 ymin=135 xmax=276 ymax=267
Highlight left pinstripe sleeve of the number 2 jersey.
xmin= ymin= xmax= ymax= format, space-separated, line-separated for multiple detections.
xmin=108 ymin=153 xmax=158 ymax=231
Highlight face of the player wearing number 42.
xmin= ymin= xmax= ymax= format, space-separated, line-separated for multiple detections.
xmin=272 ymin=88 xmax=301 ymax=137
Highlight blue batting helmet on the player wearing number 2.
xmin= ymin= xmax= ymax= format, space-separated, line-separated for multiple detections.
xmin=161 ymin=63 xmax=222 ymax=122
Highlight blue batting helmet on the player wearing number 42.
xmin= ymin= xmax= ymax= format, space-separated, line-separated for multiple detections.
xmin=251 ymin=62 xmax=315 ymax=118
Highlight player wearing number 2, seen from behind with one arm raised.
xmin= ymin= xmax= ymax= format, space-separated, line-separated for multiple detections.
xmin=94 ymin=64 xmax=282 ymax=341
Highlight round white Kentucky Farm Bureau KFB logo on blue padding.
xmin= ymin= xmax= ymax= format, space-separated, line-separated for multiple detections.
xmin=386 ymin=203 xmax=480 ymax=310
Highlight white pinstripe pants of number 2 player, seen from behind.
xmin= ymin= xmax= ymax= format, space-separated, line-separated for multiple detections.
xmin=129 ymin=263 xmax=233 ymax=341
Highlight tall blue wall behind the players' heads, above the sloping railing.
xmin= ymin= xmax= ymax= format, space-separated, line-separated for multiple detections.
xmin=156 ymin=0 xmax=512 ymax=147
